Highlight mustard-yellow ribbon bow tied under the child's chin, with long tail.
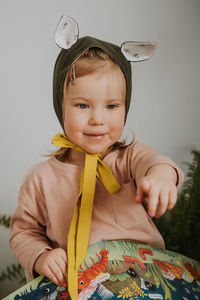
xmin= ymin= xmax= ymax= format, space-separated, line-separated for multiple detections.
xmin=52 ymin=133 xmax=120 ymax=300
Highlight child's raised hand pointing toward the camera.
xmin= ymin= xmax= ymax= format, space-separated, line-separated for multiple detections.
xmin=135 ymin=164 xmax=177 ymax=218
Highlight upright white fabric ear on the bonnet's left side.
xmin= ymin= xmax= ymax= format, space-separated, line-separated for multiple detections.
xmin=55 ymin=16 xmax=79 ymax=49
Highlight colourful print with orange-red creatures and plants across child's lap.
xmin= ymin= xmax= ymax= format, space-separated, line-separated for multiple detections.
xmin=3 ymin=241 xmax=200 ymax=300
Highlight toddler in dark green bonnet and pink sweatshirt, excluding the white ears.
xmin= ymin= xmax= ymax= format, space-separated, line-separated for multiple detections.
xmin=10 ymin=19 xmax=183 ymax=300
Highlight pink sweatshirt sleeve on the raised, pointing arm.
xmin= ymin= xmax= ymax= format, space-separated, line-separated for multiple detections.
xmin=130 ymin=142 xmax=184 ymax=189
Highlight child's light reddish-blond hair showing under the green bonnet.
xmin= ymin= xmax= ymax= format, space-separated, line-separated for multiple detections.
xmin=49 ymin=47 xmax=126 ymax=161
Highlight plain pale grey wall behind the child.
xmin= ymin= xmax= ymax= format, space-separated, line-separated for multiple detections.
xmin=0 ymin=0 xmax=200 ymax=296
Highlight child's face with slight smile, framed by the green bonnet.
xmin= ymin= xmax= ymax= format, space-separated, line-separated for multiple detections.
xmin=63 ymin=68 xmax=126 ymax=154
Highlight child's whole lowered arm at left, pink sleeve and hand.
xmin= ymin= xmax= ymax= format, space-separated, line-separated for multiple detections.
xmin=10 ymin=169 xmax=67 ymax=285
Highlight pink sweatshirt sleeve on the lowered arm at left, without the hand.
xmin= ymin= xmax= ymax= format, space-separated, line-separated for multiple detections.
xmin=10 ymin=166 xmax=52 ymax=277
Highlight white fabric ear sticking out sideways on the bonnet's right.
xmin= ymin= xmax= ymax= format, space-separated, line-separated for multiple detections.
xmin=121 ymin=42 xmax=156 ymax=62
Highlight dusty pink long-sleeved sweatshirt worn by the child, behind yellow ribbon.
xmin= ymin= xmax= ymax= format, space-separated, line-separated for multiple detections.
xmin=10 ymin=142 xmax=183 ymax=276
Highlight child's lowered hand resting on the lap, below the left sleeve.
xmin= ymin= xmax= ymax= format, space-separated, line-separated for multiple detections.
xmin=34 ymin=248 xmax=67 ymax=286
